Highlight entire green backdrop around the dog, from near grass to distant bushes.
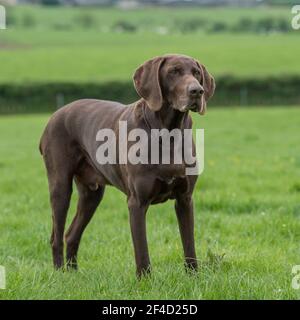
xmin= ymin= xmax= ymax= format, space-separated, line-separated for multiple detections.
xmin=0 ymin=0 xmax=300 ymax=299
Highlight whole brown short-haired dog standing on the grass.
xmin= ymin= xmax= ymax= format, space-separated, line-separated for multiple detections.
xmin=40 ymin=55 xmax=215 ymax=276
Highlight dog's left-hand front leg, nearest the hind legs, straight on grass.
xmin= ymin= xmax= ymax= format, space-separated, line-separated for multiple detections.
xmin=128 ymin=198 xmax=150 ymax=278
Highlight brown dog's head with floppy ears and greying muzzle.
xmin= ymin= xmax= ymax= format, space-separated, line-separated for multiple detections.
xmin=133 ymin=55 xmax=215 ymax=114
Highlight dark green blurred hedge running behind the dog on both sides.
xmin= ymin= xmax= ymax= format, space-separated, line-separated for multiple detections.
xmin=0 ymin=75 xmax=300 ymax=114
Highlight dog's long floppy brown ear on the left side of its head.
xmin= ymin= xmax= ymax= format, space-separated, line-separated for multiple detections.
xmin=133 ymin=57 xmax=165 ymax=111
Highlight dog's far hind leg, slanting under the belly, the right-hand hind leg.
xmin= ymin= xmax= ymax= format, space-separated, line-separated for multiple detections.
xmin=65 ymin=177 xmax=105 ymax=269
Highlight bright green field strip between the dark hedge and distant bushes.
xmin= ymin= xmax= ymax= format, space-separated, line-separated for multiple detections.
xmin=0 ymin=31 xmax=300 ymax=83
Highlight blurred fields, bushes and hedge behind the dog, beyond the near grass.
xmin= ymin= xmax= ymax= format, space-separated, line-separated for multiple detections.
xmin=0 ymin=0 xmax=300 ymax=113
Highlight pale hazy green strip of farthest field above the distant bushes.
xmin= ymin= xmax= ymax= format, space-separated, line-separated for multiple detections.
xmin=7 ymin=5 xmax=291 ymax=31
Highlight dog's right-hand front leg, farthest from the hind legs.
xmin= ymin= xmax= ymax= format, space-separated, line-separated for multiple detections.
xmin=175 ymin=196 xmax=197 ymax=270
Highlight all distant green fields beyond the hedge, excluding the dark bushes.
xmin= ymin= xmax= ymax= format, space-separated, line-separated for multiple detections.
xmin=0 ymin=6 xmax=300 ymax=83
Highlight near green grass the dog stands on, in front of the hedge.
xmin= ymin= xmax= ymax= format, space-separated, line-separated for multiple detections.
xmin=0 ymin=107 xmax=300 ymax=299
